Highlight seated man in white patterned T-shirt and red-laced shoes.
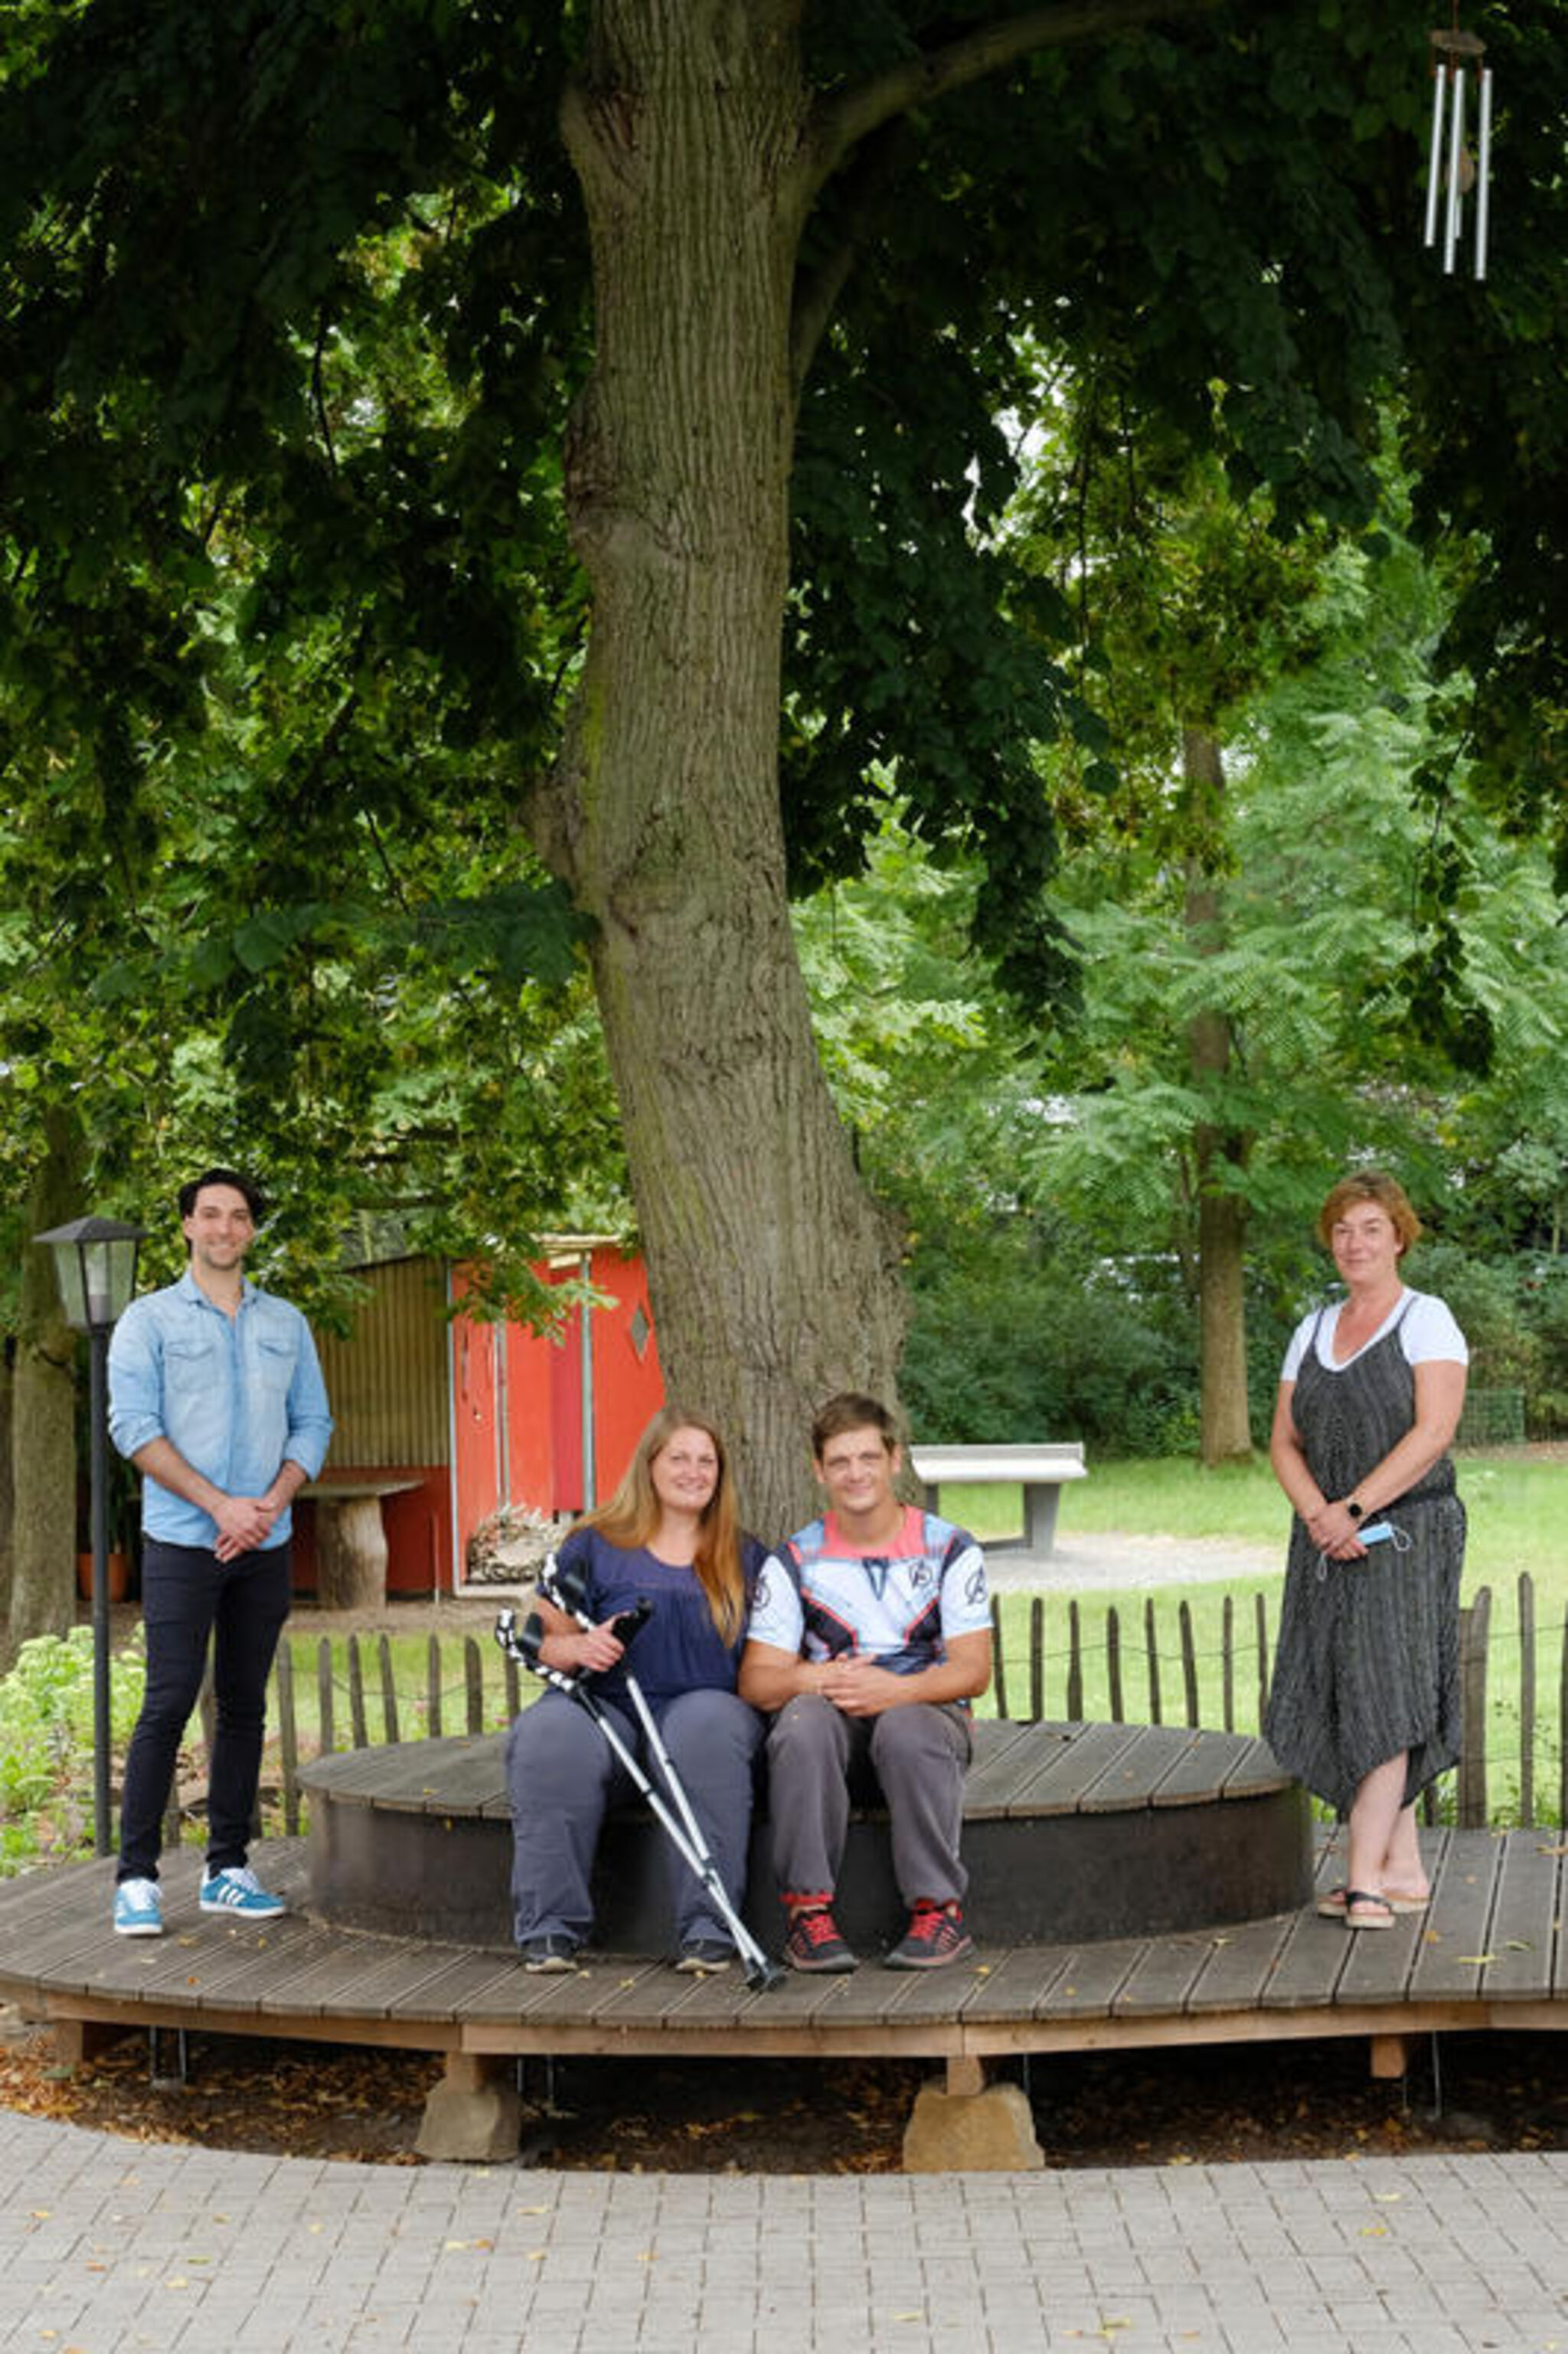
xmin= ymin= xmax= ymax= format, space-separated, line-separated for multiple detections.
xmin=740 ymin=1394 xmax=991 ymax=1970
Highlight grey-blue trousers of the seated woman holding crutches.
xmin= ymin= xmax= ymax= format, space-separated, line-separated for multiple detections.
xmin=506 ymin=1690 xmax=763 ymax=1944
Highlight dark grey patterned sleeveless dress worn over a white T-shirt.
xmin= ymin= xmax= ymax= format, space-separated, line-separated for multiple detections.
xmin=1264 ymin=1302 xmax=1465 ymax=1815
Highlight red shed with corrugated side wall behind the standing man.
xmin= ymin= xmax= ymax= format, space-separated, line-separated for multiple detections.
xmin=294 ymin=1236 xmax=664 ymax=1594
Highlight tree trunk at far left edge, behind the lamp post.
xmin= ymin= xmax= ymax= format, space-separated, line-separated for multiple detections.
xmin=7 ymin=1111 xmax=83 ymax=1657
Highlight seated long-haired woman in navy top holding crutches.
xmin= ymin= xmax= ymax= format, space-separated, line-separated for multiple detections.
xmin=506 ymin=1405 xmax=763 ymax=1973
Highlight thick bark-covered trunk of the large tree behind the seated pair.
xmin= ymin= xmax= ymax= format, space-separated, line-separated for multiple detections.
xmin=528 ymin=0 xmax=904 ymax=1537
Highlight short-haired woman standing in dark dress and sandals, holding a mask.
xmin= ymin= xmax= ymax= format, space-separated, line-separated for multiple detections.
xmin=1264 ymin=1170 xmax=1469 ymax=1928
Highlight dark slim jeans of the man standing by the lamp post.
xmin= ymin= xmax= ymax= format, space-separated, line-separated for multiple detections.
xmin=118 ymin=1539 xmax=292 ymax=1881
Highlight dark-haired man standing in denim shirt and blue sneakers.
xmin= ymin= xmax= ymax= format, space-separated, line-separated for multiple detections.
xmin=108 ymin=1170 xmax=332 ymax=1937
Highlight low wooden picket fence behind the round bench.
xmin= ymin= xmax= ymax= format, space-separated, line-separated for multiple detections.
xmin=226 ymin=1572 xmax=1568 ymax=1834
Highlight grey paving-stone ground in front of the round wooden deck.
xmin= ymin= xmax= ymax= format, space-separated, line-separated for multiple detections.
xmin=0 ymin=2111 xmax=1568 ymax=2354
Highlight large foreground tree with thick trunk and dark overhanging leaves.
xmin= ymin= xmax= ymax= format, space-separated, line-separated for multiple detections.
xmin=0 ymin=0 xmax=1568 ymax=1523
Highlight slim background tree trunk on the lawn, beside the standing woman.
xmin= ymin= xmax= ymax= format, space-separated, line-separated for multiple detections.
xmin=1182 ymin=727 xmax=1253 ymax=1464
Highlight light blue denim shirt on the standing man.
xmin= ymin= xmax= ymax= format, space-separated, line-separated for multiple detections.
xmin=108 ymin=1269 xmax=332 ymax=1551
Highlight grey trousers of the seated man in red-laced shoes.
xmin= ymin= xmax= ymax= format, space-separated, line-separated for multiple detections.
xmin=767 ymin=1692 xmax=972 ymax=1904
